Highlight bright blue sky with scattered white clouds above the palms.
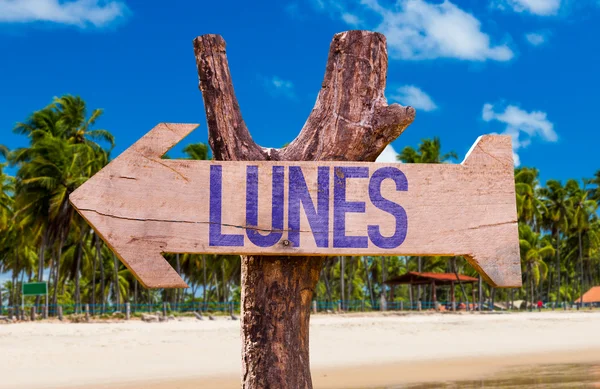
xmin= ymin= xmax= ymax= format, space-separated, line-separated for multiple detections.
xmin=0 ymin=0 xmax=600 ymax=185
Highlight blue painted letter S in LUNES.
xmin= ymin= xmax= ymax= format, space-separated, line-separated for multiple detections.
xmin=368 ymin=167 xmax=408 ymax=249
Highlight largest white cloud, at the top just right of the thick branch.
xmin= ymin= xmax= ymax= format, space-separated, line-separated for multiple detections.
xmin=313 ymin=0 xmax=514 ymax=61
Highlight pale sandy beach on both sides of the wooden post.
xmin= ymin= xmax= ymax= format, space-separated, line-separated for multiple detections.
xmin=0 ymin=311 xmax=600 ymax=389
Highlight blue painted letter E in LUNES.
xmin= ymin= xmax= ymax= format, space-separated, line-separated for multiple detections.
xmin=333 ymin=167 xmax=369 ymax=248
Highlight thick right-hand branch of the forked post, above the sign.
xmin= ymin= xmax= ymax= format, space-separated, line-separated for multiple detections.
xmin=281 ymin=31 xmax=415 ymax=161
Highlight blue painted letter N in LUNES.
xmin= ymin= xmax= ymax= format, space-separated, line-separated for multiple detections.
xmin=288 ymin=166 xmax=329 ymax=247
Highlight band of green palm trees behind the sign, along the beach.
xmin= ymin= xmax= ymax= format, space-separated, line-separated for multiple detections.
xmin=0 ymin=95 xmax=600 ymax=308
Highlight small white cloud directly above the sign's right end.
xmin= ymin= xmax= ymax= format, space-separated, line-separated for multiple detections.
xmin=481 ymin=103 xmax=558 ymax=166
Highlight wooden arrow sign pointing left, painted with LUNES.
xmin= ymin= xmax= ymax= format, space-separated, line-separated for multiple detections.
xmin=70 ymin=123 xmax=521 ymax=288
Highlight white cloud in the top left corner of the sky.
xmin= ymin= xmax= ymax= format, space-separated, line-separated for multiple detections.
xmin=0 ymin=0 xmax=128 ymax=27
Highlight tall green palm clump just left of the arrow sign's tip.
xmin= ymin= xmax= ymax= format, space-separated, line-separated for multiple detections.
xmin=10 ymin=95 xmax=114 ymax=312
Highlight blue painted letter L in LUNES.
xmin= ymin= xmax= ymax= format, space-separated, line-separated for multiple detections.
xmin=208 ymin=165 xmax=244 ymax=246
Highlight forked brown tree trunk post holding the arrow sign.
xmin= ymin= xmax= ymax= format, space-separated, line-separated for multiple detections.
xmin=194 ymin=31 xmax=415 ymax=389
